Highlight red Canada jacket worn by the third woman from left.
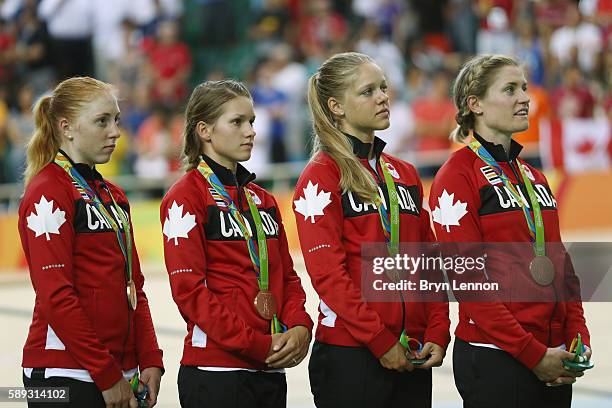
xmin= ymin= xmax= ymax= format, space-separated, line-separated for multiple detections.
xmin=294 ymin=136 xmax=450 ymax=358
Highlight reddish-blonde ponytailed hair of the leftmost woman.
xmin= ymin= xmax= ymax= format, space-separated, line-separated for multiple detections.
xmin=24 ymin=77 xmax=114 ymax=186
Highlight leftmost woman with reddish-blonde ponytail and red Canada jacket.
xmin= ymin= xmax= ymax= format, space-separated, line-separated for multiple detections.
xmin=19 ymin=77 xmax=163 ymax=408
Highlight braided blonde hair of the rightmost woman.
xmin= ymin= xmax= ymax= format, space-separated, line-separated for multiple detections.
xmin=450 ymin=55 xmax=520 ymax=143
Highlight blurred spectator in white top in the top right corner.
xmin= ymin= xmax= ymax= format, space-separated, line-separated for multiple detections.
xmin=550 ymin=4 xmax=603 ymax=74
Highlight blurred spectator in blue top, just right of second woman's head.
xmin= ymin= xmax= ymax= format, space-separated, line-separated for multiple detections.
xmin=251 ymin=61 xmax=288 ymax=163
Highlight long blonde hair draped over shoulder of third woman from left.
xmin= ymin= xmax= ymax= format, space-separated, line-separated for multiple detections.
xmin=308 ymin=52 xmax=376 ymax=202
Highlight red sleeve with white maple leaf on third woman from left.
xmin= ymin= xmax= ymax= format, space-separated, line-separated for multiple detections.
xmin=294 ymin=162 xmax=398 ymax=358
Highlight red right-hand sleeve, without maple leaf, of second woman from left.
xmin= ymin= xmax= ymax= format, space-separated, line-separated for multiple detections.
xmin=274 ymin=196 xmax=313 ymax=331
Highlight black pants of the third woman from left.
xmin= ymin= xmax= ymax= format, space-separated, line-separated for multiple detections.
xmin=308 ymin=342 xmax=431 ymax=408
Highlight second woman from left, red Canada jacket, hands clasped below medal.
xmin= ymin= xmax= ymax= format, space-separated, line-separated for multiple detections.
xmin=160 ymin=80 xmax=312 ymax=408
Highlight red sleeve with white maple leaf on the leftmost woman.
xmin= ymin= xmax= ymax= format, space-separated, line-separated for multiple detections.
xmin=19 ymin=187 xmax=123 ymax=390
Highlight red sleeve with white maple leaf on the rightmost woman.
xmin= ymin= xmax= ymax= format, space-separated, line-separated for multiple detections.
xmin=429 ymin=164 xmax=547 ymax=369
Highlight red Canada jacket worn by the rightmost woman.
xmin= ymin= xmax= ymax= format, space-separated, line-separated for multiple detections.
xmin=429 ymin=135 xmax=590 ymax=369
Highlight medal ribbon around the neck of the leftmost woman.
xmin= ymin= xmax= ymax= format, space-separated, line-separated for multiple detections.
xmin=54 ymin=152 xmax=132 ymax=282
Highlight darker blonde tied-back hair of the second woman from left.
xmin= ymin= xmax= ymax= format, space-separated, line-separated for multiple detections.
xmin=182 ymin=79 xmax=252 ymax=171
